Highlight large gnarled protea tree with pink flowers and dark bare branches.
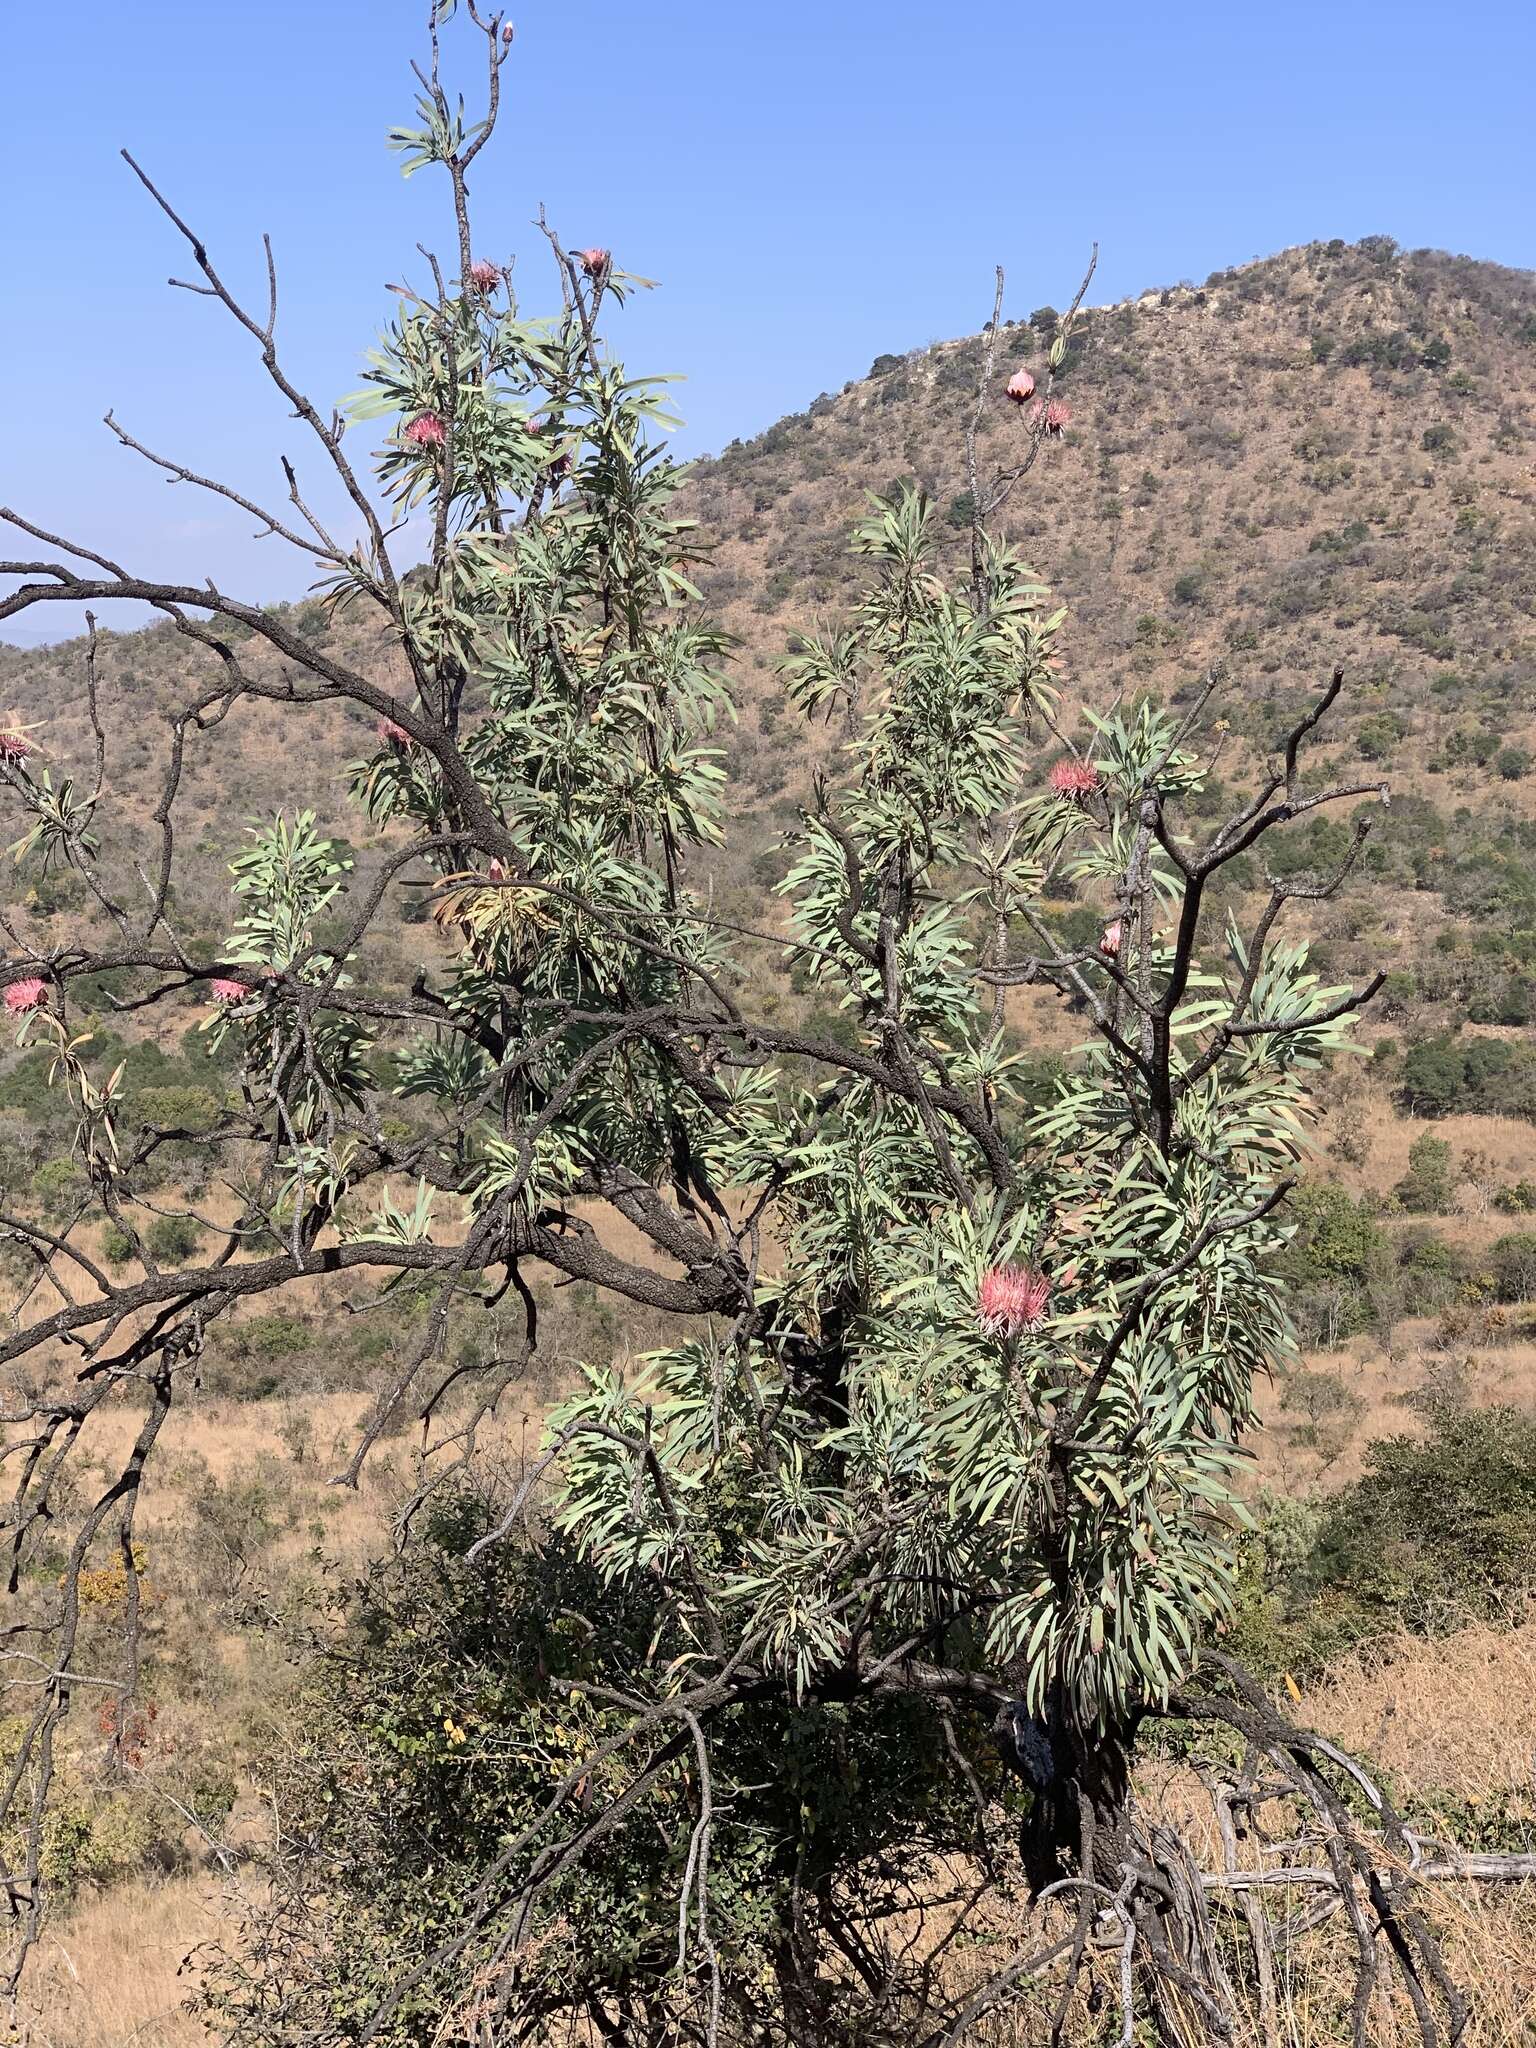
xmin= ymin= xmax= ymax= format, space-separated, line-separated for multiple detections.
xmin=0 ymin=4 xmax=1507 ymax=2044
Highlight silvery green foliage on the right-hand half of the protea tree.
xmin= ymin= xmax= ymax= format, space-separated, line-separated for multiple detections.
xmin=553 ymin=494 xmax=1343 ymax=1724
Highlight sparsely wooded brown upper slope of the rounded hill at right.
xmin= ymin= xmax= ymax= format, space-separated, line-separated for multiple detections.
xmin=694 ymin=242 xmax=1536 ymax=801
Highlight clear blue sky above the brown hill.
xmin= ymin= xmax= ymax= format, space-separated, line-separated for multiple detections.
xmin=0 ymin=0 xmax=1536 ymax=639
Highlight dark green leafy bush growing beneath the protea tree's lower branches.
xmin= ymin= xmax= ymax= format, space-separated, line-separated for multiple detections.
xmin=213 ymin=1499 xmax=987 ymax=2048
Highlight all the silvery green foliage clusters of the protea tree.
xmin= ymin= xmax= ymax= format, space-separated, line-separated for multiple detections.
xmin=198 ymin=228 xmax=1368 ymax=1724
